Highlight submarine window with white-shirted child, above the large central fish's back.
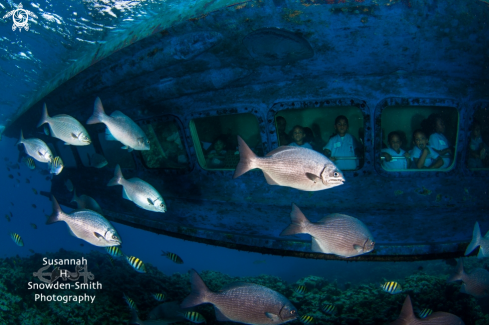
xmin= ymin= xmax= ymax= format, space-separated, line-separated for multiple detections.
xmin=275 ymin=106 xmax=364 ymax=170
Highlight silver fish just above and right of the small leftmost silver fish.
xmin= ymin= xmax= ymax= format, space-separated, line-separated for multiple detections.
xmin=37 ymin=104 xmax=92 ymax=146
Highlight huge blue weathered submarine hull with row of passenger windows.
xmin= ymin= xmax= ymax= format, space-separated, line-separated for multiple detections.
xmin=4 ymin=0 xmax=489 ymax=261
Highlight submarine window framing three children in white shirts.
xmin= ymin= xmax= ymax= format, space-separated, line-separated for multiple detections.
xmin=376 ymin=106 xmax=459 ymax=172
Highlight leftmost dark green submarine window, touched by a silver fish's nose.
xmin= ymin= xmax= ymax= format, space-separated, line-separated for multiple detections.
xmin=141 ymin=121 xmax=189 ymax=169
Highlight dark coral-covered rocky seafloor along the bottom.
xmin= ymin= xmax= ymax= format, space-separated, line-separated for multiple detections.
xmin=0 ymin=250 xmax=489 ymax=325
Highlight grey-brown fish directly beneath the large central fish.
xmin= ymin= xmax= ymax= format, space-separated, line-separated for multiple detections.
xmin=280 ymin=204 xmax=375 ymax=257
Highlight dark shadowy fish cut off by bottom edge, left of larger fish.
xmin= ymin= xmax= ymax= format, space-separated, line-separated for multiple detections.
xmin=129 ymin=301 xmax=185 ymax=325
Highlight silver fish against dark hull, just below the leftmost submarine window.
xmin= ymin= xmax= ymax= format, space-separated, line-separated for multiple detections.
xmin=107 ymin=165 xmax=166 ymax=212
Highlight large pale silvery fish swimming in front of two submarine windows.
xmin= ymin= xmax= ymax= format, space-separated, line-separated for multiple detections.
xmin=233 ymin=136 xmax=345 ymax=191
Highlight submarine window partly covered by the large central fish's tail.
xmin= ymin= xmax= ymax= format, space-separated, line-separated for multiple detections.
xmin=190 ymin=113 xmax=263 ymax=170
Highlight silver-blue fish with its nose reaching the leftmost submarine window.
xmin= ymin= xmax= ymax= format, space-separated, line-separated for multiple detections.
xmin=87 ymin=97 xmax=149 ymax=151
